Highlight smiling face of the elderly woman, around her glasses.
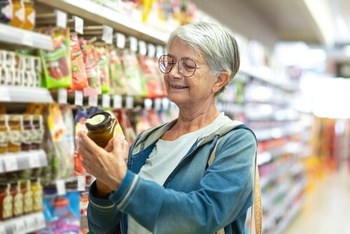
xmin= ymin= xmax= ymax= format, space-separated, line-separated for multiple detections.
xmin=164 ymin=38 xmax=216 ymax=107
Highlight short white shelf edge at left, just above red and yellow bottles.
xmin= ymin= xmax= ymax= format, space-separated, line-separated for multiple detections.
xmin=0 ymin=150 xmax=47 ymax=173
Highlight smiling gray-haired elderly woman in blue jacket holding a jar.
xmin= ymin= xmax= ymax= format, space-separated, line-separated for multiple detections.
xmin=79 ymin=22 xmax=257 ymax=234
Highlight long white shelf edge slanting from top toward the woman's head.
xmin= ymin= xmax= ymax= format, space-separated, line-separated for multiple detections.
xmin=36 ymin=0 xmax=169 ymax=45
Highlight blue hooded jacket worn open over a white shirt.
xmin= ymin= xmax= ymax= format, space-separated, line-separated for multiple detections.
xmin=88 ymin=121 xmax=257 ymax=234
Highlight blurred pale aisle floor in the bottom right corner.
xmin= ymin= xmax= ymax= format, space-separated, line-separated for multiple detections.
xmin=285 ymin=165 xmax=350 ymax=234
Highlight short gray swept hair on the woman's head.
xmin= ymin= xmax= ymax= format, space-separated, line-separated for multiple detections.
xmin=167 ymin=22 xmax=240 ymax=88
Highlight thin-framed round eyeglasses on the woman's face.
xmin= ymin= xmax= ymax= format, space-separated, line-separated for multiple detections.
xmin=158 ymin=55 xmax=197 ymax=77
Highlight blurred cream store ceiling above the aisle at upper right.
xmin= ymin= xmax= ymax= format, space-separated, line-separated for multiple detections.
xmin=193 ymin=0 xmax=350 ymax=47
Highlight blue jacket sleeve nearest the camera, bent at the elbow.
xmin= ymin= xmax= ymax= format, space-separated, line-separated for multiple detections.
xmin=108 ymin=129 xmax=257 ymax=234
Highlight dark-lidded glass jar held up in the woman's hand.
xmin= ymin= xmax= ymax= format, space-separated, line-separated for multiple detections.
xmin=85 ymin=112 xmax=123 ymax=148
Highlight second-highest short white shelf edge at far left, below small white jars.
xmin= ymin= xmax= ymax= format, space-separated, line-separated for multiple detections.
xmin=0 ymin=86 xmax=53 ymax=103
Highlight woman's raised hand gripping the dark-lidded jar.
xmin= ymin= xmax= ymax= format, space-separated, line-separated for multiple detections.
xmin=78 ymin=132 xmax=129 ymax=194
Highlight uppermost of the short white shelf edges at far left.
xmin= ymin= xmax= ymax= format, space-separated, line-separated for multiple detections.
xmin=0 ymin=24 xmax=53 ymax=50
